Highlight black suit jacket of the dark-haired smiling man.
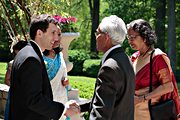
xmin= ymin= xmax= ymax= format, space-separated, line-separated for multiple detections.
xmin=9 ymin=41 xmax=64 ymax=120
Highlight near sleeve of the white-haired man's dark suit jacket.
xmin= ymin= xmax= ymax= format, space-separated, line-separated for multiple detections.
xmin=90 ymin=63 xmax=118 ymax=120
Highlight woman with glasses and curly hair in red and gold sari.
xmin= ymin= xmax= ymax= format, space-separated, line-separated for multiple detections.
xmin=127 ymin=19 xmax=180 ymax=120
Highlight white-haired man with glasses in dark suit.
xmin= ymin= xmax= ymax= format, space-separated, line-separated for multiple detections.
xmin=80 ymin=15 xmax=135 ymax=120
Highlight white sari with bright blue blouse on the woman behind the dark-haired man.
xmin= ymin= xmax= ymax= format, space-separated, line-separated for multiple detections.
xmin=43 ymin=52 xmax=68 ymax=120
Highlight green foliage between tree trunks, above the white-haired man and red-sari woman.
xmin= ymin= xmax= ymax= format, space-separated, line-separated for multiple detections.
xmin=104 ymin=0 xmax=155 ymax=23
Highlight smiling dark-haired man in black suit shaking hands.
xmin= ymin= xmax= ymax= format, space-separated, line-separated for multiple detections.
xmin=9 ymin=14 xmax=78 ymax=120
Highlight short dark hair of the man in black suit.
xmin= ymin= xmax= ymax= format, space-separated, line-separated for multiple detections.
xmin=29 ymin=14 xmax=58 ymax=40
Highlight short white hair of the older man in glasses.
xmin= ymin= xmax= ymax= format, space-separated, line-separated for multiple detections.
xmin=99 ymin=15 xmax=127 ymax=45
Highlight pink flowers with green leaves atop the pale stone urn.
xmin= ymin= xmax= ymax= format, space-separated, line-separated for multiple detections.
xmin=54 ymin=15 xmax=77 ymax=32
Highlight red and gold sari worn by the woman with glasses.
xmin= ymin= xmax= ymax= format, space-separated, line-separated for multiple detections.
xmin=131 ymin=48 xmax=180 ymax=120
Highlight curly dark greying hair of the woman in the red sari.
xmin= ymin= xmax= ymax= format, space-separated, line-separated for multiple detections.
xmin=127 ymin=19 xmax=157 ymax=46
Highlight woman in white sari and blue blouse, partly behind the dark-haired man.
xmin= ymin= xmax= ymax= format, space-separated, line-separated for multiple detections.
xmin=43 ymin=30 xmax=69 ymax=120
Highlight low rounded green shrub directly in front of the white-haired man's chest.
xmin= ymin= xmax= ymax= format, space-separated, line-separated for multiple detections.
xmin=83 ymin=59 xmax=101 ymax=77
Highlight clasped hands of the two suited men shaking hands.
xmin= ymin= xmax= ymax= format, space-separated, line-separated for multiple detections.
xmin=64 ymin=100 xmax=80 ymax=117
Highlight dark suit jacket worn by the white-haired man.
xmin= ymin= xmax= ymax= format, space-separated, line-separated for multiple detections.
xmin=80 ymin=47 xmax=135 ymax=120
